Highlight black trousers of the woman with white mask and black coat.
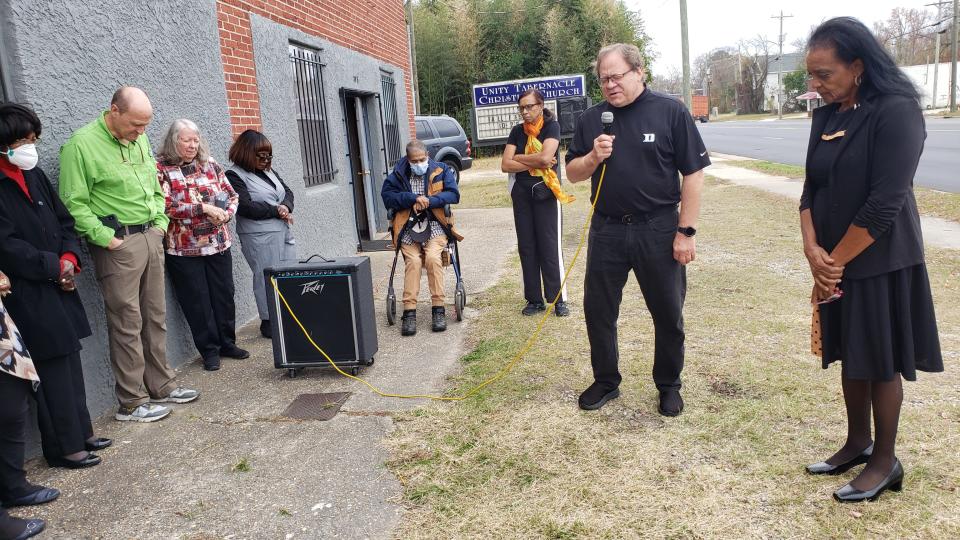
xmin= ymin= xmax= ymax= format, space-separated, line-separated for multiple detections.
xmin=33 ymin=351 xmax=93 ymax=459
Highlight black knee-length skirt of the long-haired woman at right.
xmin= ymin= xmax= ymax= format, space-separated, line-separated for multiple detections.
xmin=820 ymin=264 xmax=943 ymax=381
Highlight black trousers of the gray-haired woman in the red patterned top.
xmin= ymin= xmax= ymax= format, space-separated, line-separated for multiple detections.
xmin=166 ymin=249 xmax=237 ymax=359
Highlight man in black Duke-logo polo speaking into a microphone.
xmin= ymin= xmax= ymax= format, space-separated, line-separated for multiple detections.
xmin=566 ymin=44 xmax=710 ymax=416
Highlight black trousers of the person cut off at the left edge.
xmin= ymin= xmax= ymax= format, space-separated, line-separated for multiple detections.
xmin=0 ymin=372 xmax=36 ymax=504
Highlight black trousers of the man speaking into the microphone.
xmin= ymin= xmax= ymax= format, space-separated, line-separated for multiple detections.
xmin=583 ymin=211 xmax=687 ymax=390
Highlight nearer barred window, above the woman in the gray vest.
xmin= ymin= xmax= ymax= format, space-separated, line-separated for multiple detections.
xmin=289 ymin=43 xmax=337 ymax=187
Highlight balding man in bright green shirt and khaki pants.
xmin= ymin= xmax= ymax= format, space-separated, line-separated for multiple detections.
xmin=60 ymin=86 xmax=200 ymax=422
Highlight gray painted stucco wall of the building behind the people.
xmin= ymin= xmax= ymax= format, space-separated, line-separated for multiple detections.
xmin=0 ymin=0 xmax=408 ymax=426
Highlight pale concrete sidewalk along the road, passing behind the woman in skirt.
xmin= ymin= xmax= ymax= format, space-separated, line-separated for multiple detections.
xmin=706 ymin=152 xmax=960 ymax=249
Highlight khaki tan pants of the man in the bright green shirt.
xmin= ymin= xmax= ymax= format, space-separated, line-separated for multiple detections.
xmin=90 ymin=228 xmax=176 ymax=408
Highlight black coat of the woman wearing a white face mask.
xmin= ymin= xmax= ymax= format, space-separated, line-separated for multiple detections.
xmin=0 ymin=168 xmax=90 ymax=361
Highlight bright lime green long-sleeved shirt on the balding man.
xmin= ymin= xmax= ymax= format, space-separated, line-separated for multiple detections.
xmin=60 ymin=113 xmax=170 ymax=247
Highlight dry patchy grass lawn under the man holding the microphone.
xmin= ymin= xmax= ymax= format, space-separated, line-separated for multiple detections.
xmin=387 ymin=176 xmax=960 ymax=539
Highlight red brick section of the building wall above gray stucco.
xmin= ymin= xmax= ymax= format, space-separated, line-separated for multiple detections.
xmin=217 ymin=0 xmax=414 ymax=136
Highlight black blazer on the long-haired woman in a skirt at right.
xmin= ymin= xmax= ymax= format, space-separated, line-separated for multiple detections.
xmin=800 ymin=96 xmax=927 ymax=279
